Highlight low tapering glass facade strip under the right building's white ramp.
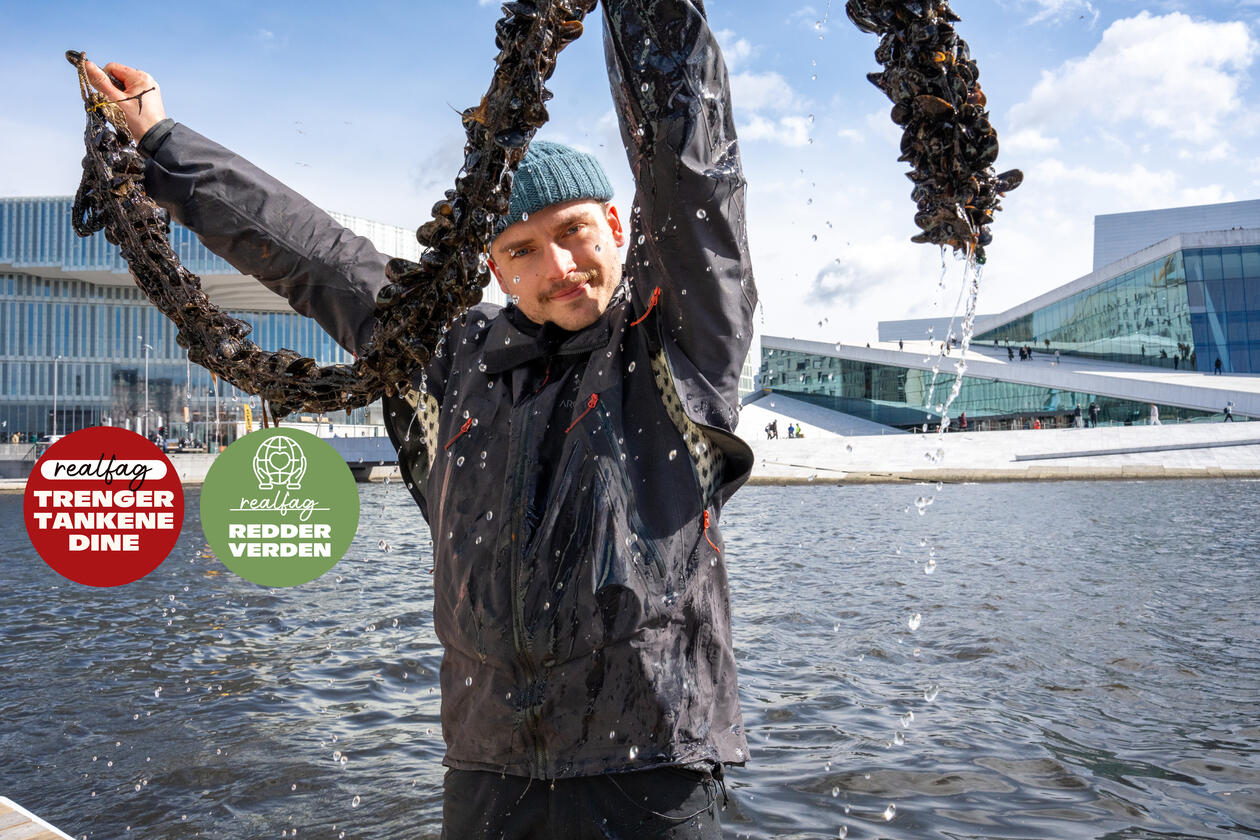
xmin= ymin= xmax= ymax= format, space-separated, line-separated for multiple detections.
xmin=761 ymin=348 xmax=1221 ymax=431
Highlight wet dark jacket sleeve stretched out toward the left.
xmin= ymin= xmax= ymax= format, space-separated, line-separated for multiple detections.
xmin=145 ymin=123 xmax=388 ymax=353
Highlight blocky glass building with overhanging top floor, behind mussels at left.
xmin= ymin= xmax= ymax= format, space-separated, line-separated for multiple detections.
xmin=0 ymin=198 xmax=501 ymax=442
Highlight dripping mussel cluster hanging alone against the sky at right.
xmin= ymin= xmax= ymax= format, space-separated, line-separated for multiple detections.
xmin=845 ymin=0 xmax=1023 ymax=262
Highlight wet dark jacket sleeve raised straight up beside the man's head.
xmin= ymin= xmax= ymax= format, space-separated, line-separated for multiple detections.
xmin=604 ymin=0 xmax=757 ymax=431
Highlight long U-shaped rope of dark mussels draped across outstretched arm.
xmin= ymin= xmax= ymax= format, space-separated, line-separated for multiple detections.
xmin=66 ymin=0 xmax=596 ymax=419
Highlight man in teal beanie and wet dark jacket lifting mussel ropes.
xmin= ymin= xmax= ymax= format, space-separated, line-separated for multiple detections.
xmin=92 ymin=0 xmax=756 ymax=839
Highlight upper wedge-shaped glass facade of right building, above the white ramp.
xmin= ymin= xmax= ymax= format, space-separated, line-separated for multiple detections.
xmin=975 ymin=246 xmax=1260 ymax=373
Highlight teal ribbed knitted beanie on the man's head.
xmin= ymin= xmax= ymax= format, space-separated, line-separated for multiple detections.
xmin=496 ymin=140 xmax=612 ymax=233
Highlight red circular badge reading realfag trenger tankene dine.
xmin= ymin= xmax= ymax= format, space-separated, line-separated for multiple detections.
xmin=24 ymin=426 xmax=184 ymax=587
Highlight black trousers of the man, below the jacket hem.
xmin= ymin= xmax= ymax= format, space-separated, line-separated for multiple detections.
xmin=442 ymin=767 xmax=726 ymax=840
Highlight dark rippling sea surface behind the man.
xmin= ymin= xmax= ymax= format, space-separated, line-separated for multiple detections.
xmin=0 ymin=481 xmax=1260 ymax=840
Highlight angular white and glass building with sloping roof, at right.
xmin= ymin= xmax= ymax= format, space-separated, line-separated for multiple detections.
xmin=761 ymin=201 xmax=1260 ymax=429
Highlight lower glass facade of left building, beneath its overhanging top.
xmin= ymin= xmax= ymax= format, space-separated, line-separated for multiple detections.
xmin=0 ymin=273 xmax=362 ymax=442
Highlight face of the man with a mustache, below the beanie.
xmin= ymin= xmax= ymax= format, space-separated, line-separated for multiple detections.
xmin=490 ymin=200 xmax=626 ymax=330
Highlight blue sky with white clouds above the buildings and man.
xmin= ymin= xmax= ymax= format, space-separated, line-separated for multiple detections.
xmin=0 ymin=0 xmax=1260 ymax=343
